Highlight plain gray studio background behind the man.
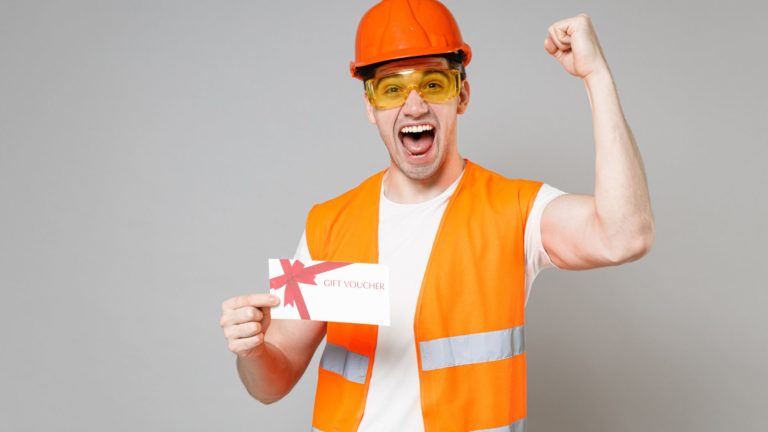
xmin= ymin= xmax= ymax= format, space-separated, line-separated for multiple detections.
xmin=0 ymin=0 xmax=768 ymax=432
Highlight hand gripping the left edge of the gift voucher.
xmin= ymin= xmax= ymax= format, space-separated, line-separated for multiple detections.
xmin=219 ymin=294 xmax=280 ymax=357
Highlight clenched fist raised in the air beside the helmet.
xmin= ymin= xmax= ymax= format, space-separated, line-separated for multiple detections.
xmin=544 ymin=14 xmax=608 ymax=79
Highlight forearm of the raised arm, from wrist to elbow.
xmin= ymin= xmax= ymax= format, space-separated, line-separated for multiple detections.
xmin=584 ymin=65 xmax=655 ymax=261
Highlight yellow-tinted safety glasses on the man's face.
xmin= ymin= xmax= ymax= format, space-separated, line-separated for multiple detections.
xmin=365 ymin=69 xmax=461 ymax=109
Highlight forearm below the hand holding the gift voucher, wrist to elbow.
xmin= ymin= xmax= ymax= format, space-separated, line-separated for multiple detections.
xmin=237 ymin=342 xmax=298 ymax=404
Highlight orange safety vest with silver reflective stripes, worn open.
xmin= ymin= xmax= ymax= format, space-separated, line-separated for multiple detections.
xmin=306 ymin=161 xmax=541 ymax=432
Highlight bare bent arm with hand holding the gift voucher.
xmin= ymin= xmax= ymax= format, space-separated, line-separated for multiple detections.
xmin=220 ymin=294 xmax=325 ymax=403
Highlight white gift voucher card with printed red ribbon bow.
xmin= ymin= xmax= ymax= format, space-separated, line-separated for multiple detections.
xmin=269 ymin=259 xmax=389 ymax=325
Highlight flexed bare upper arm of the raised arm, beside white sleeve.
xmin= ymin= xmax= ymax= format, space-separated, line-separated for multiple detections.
xmin=541 ymin=194 xmax=613 ymax=270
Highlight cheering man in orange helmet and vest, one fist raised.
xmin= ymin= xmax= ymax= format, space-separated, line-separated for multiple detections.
xmin=220 ymin=0 xmax=654 ymax=431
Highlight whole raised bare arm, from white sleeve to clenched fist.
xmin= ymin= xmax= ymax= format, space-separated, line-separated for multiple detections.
xmin=541 ymin=14 xmax=655 ymax=270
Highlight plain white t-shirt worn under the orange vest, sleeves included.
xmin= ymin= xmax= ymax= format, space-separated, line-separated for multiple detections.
xmin=295 ymin=174 xmax=565 ymax=432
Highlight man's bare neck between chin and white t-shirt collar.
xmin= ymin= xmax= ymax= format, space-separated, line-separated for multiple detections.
xmin=382 ymin=153 xmax=464 ymax=204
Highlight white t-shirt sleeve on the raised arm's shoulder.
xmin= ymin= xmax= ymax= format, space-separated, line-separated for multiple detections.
xmin=524 ymin=183 xmax=565 ymax=303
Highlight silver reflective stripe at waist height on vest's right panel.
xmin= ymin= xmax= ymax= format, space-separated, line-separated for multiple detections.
xmin=419 ymin=326 xmax=525 ymax=371
